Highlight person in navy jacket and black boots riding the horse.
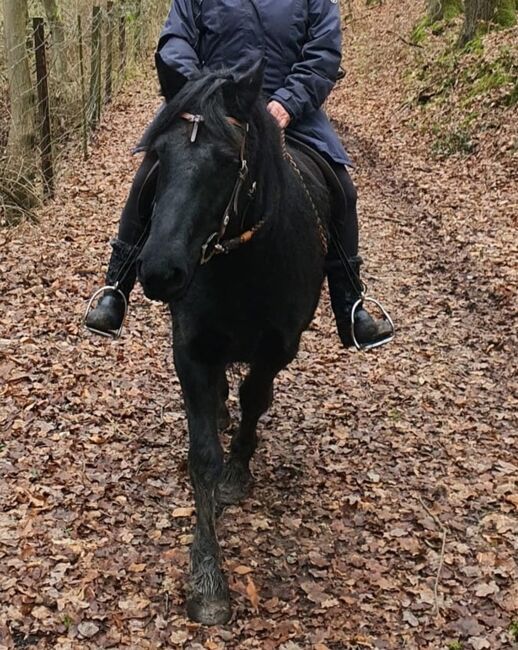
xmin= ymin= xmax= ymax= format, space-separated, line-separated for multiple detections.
xmin=86 ymin=0 xmax=391 ymax=347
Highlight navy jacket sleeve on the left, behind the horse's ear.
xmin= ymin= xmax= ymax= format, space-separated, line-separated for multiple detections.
xmin=156 ymin=0 xmax=200 ymax=85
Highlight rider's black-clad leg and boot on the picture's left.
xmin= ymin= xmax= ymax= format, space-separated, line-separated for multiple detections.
xmin=86 ymin=154 xmax=156 ymax=333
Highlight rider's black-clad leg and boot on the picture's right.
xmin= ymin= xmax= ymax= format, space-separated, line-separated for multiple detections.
xmin=326 ymin=163 xmax=391 ymax=347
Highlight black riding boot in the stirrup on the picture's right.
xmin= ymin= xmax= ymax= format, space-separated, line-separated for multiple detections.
xmin=326 ymin=256 xmax=393 ymax=348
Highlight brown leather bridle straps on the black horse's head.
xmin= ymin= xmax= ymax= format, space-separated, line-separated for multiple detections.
xmin=180 ymin=113 xmax=265 ymax=264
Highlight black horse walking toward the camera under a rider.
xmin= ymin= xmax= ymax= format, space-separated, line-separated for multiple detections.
xmin=137 ymin=67 xmax=332 ymax=625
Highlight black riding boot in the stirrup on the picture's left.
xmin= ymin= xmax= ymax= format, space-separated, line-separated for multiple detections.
xmin=85 ymin=239 xmax=137 ymax=335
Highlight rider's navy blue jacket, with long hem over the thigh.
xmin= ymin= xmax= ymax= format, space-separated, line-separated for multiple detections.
xmin=157 ymin=0 xmax=350 ymax=164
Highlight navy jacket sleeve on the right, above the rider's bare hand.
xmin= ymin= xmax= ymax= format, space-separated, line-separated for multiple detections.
xmin=271 ymin=0 xmax=342 ymax=120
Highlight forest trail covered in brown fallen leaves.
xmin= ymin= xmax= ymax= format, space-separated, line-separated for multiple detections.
xmin=0 ymin=3 xmax=518 ymax=650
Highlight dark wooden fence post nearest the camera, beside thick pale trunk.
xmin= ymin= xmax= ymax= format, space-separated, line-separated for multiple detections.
xmin=33 ymin=18 xmax=54 ymax=197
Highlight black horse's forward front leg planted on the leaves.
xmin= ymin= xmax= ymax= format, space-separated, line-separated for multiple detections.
xmin=175 ymin=349 xmax=231 ymax=625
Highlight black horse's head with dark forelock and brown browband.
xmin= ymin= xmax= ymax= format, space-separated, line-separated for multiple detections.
xmin=137 ymin=66 xmax=262 ymax=302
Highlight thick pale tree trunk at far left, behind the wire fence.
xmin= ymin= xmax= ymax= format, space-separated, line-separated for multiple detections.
xmin=3 ymin=0 xmax=35 ymax=180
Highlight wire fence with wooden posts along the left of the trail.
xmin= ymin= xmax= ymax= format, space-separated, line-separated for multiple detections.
xmin=0 ymin=0 xmax=171 ymax=224
